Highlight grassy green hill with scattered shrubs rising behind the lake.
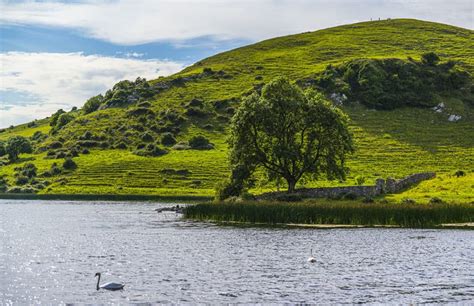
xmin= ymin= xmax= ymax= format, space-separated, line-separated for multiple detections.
xmin=0 ymin=19 xmax=474 ymax=202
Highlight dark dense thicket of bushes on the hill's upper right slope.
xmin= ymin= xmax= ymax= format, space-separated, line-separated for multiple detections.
xmin=312 ymin=53 xmax=472 ymax=109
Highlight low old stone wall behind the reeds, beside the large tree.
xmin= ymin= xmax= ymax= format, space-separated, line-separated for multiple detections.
xmin=257 ymin=172 xmax=436 ymax=200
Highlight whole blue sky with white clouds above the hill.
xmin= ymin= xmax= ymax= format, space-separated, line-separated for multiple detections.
xmin=0 ymin=0 xmax=474 ymax=127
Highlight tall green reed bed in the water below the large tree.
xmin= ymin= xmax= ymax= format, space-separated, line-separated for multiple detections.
xmin=184 ymin=201 xmax=474 ymax=227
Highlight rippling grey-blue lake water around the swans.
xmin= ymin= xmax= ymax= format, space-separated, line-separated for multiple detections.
xmin=0 ymin=200 xmax=474 ymax=304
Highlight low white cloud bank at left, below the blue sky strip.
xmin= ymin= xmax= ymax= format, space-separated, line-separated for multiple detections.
xmin=0 ymin=52 xmax=183 ymax=127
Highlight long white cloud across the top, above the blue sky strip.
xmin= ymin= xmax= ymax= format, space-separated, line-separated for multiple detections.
xmin=0 ymin=0 xmax=473 ymax=45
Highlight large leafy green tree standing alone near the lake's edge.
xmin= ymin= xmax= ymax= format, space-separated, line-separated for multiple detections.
xmin=229 ymin=78 xmax=354 ymax=193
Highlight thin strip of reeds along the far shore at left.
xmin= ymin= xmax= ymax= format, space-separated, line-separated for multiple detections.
xmin=0 ymin=193 xmax=213 ymax=203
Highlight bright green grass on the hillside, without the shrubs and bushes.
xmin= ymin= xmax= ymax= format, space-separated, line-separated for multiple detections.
xmin=0 ymin=19 xmax=474 ymax=202
